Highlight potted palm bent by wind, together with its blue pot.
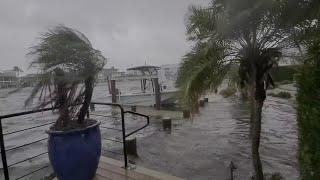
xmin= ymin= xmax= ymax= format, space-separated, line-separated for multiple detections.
xmin=25 ymin=25 xmax=106 ymax=180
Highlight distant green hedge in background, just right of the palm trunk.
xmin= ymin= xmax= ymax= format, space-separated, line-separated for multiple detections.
xmin=271 ymin=65 xmax=299 ymax=82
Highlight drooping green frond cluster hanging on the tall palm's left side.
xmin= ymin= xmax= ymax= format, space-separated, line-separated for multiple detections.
xmin=177 ymin=43 xmax=230 ymax=110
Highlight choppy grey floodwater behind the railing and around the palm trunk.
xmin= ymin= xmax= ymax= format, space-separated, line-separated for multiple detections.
xmin=0 ymin=85 xmax=298 ymax=180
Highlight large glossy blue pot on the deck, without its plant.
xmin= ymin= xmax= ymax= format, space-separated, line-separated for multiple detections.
xmin=47 ymin=121 xmax=101 ymax=180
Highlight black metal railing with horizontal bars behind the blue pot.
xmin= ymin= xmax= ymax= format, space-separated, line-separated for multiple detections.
xmin=0 ymin=102 xmax=150 ymax=180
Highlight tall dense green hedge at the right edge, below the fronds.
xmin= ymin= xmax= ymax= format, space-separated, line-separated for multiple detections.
xmin=297 ymin=63 xmax=320 ymax=180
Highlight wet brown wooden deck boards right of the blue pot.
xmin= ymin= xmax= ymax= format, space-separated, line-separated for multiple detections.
xmin=94 ymin=156 xmax=183 ymax=180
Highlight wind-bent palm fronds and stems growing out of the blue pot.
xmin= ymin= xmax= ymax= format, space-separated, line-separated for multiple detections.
xmin=25 ymin=25 xmax=106 ymax=129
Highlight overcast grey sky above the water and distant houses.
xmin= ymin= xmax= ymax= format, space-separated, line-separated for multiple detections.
xmin=0 ymin=0 xmax=208 ymax=73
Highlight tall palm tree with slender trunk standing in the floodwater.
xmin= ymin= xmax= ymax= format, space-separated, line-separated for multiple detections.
xmin=177 ymin=0 xmax=286 ymax=180
